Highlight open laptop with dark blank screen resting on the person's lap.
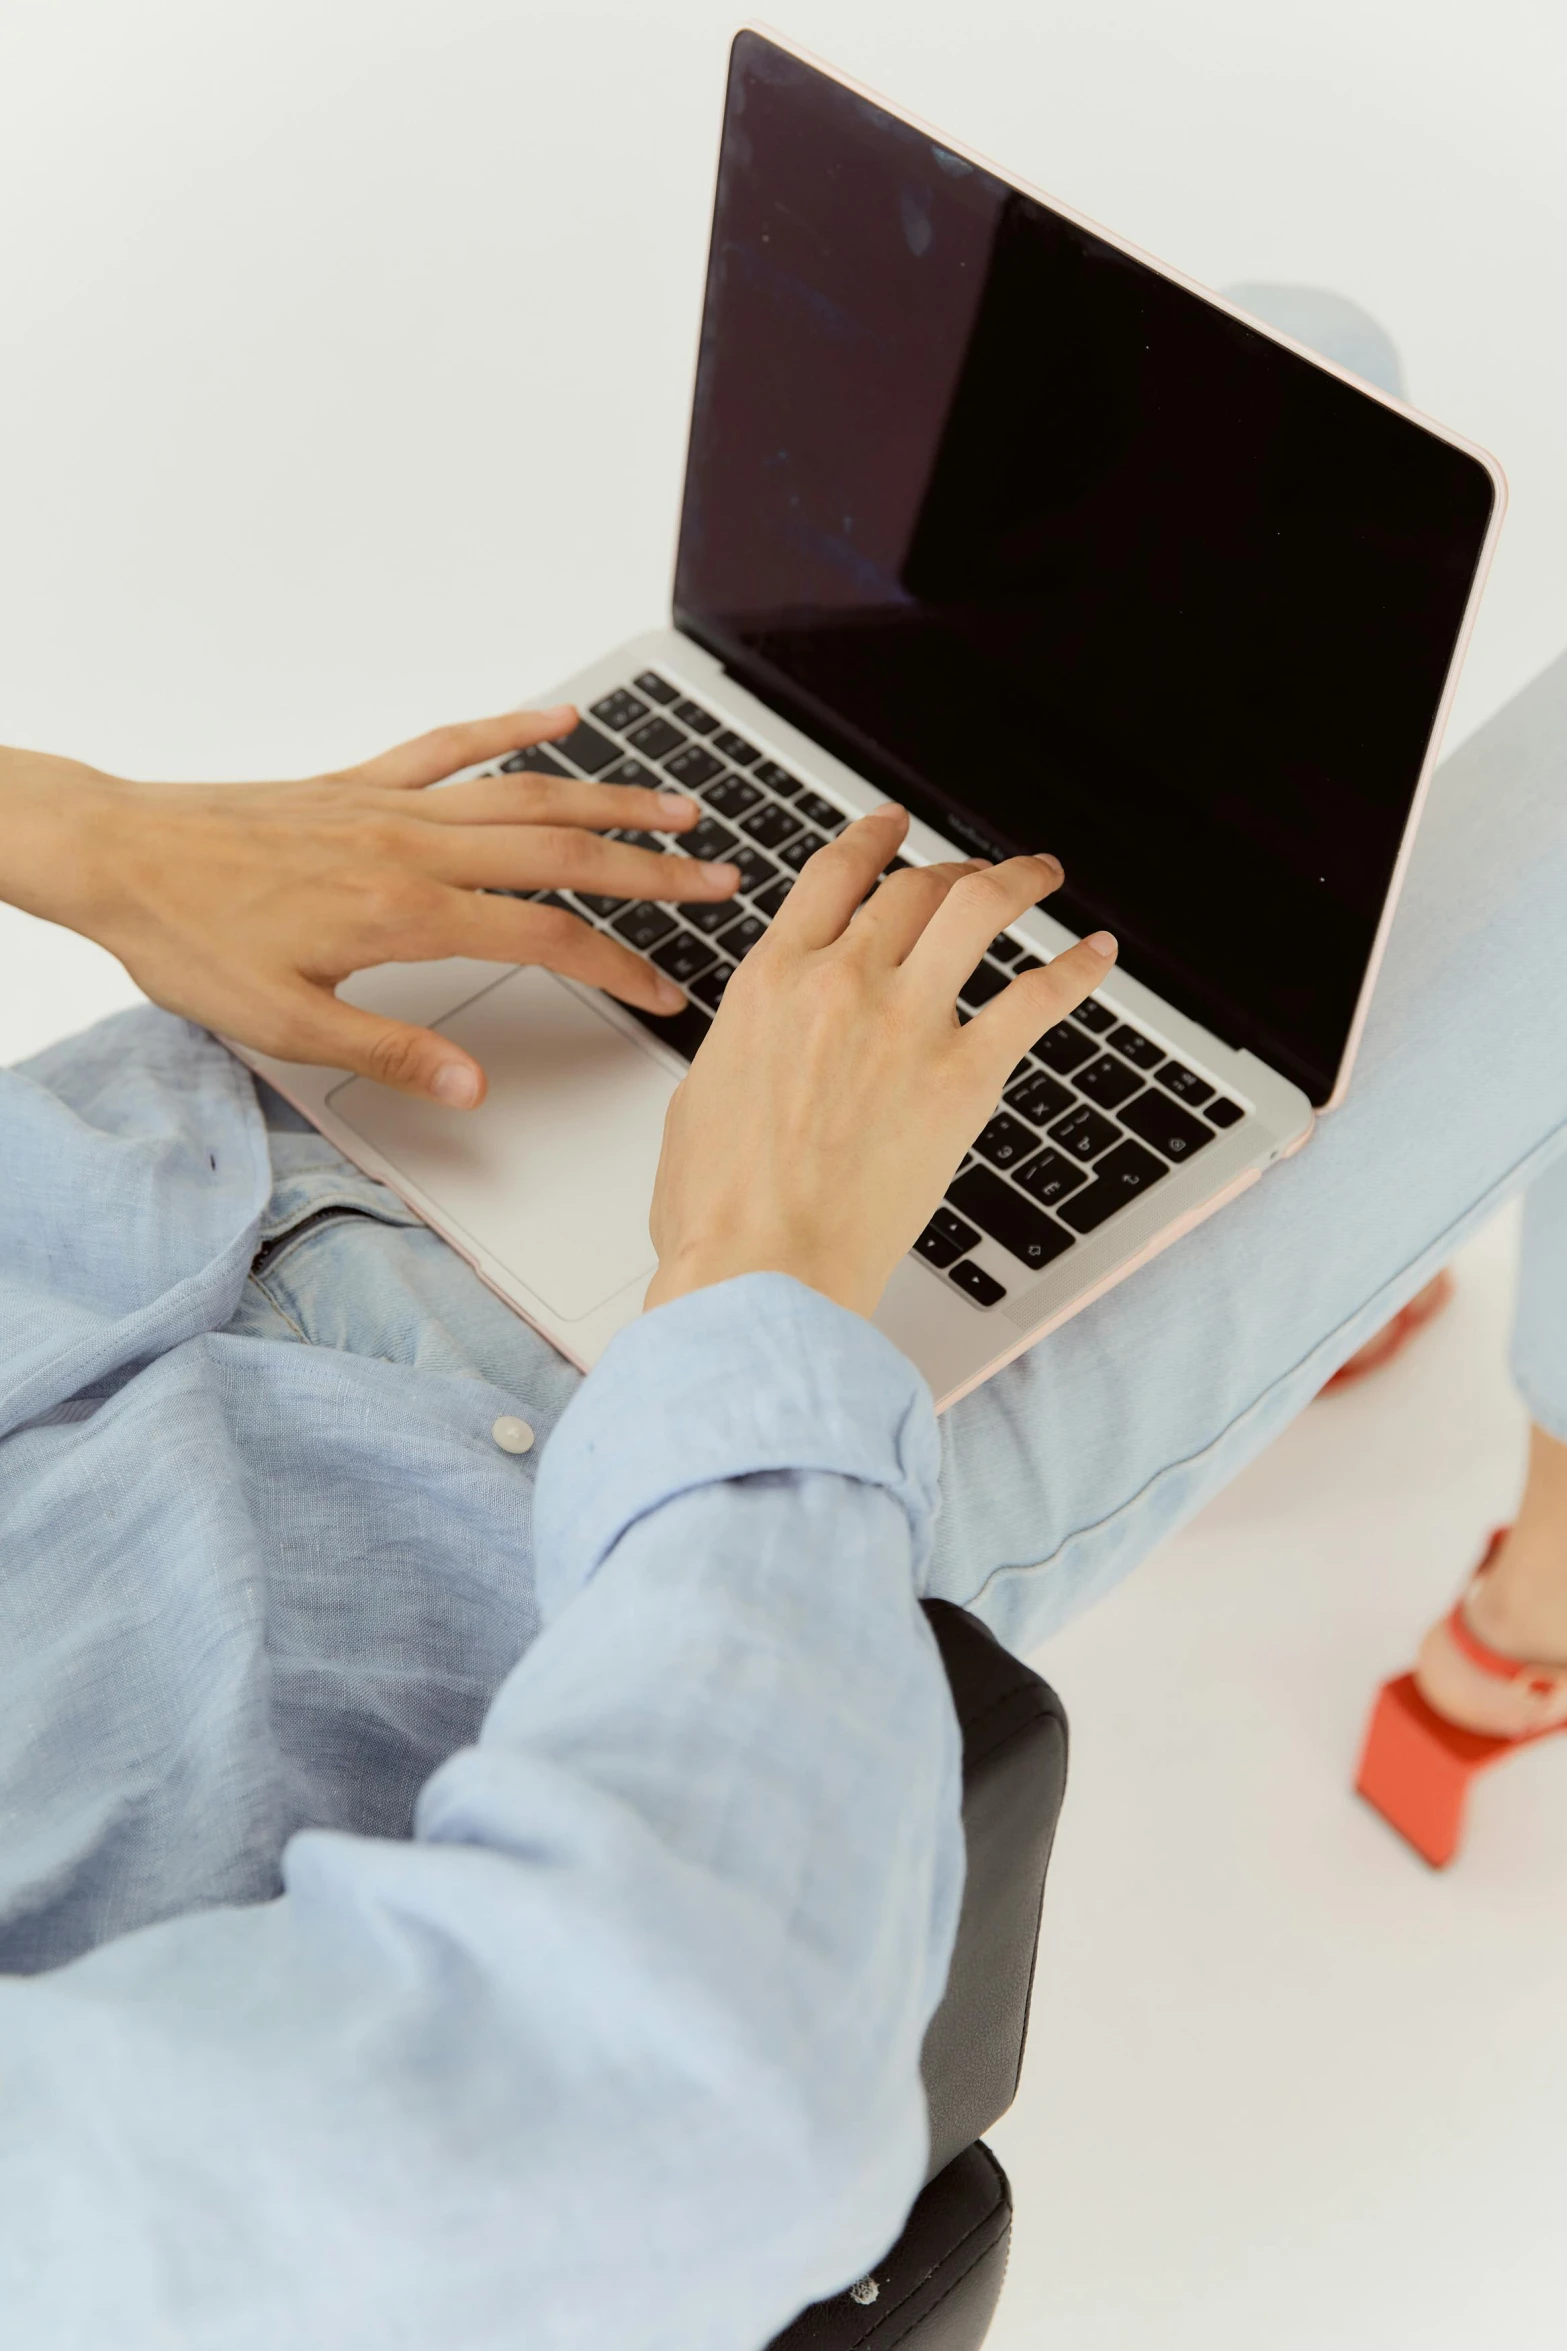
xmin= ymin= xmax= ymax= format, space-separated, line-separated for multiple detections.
xmin=244 ymin=28 xmax=1506 ymax=1406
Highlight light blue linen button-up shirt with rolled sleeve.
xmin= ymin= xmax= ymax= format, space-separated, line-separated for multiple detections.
xmin=0 ymin=1011 xmax=963 ymax=2351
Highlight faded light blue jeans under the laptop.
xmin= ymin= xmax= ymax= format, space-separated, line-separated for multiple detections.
xmin=240 ymin=287 xmax=1567 ymax=1650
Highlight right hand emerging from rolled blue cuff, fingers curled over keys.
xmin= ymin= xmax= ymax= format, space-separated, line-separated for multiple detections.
xmin=646 ymin=806 xmax=1116 ymax=1314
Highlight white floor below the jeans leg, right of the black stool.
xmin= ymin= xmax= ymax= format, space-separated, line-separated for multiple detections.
xmin=991 ymin=1194 xmax=1567 ymax=2351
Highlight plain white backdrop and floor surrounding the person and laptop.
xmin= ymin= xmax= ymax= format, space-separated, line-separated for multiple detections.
xmin=0 ymin=0 xmax=1567 ymax=2351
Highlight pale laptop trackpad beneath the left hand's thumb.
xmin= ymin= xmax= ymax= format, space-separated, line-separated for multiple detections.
xmin=327 ymin=969 xmax=679 ymax=1321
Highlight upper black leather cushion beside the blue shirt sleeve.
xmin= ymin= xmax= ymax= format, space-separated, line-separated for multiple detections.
xmin=923 ymin=1601 xmax=1067 ymax=2177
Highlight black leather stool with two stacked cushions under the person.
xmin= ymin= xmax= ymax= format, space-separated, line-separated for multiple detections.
xmin=768 ymin=1601 xmax=1067 ymax=2351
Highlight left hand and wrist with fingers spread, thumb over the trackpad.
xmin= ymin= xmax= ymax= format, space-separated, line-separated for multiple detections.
xmin=0 ymin=708 xmax=740 ymax=1110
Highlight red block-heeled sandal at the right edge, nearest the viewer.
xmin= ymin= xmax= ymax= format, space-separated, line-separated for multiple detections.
xmin=1356 ymin=1526 xmax=1567 ymax=1869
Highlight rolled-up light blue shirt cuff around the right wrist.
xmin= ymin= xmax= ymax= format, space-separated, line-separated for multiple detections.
xmin=533 ymin=1274 xmax=942 ymax=1620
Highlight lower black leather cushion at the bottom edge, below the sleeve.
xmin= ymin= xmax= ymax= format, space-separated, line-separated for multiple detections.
xmin=768 ymin=2146 xmax=1013 ymax=2351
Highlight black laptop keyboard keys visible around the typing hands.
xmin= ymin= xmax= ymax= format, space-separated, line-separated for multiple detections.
xmin=483 ymin=670 xmax=1245 ymax=1307
